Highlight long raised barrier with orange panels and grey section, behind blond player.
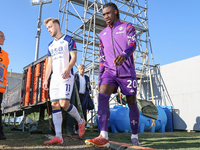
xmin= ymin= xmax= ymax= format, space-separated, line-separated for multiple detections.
xmin=2 ymin=55 xmax=49 ymax=129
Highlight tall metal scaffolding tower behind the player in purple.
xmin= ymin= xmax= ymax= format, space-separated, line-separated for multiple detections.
xmin=58 ymin=0 xmax=157 ymax=100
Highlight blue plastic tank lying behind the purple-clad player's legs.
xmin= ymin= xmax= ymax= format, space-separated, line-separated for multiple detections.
xmin=96 ymin=105 xmax=167 ymax=133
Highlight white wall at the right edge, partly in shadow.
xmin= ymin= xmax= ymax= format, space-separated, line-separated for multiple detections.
xmin=152 ymin=55 xmax=200 ymax=131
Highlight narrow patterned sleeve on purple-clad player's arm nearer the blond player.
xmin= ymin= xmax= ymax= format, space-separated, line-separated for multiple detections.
xmin=99 ymin=39 xmax=105 ymax=82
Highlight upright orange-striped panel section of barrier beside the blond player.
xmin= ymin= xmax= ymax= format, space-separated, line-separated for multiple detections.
xmin=21 ymin=56 xmax=49 ymax=107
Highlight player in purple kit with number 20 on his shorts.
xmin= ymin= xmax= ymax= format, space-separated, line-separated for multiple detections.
xmin=85 ymin=2 xmax=139 ymax=148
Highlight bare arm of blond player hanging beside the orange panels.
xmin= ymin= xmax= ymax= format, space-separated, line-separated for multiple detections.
xmin=43 ymin=56 xmax=52 ymax=90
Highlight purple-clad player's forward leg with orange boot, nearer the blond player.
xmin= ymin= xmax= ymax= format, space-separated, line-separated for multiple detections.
xmin=85 ymin=74 xmax=117 ymax=147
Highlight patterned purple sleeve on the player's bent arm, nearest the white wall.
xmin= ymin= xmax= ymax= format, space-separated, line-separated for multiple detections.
xmin=122 ymin=23 xmax=137 ymax=59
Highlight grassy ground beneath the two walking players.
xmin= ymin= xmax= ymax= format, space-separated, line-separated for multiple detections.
xmin=0 ymin=127 xmax=200 ymax=150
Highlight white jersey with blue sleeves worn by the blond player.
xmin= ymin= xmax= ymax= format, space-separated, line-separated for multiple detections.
xmin=48 ymin=35 xmax=77 ymax=77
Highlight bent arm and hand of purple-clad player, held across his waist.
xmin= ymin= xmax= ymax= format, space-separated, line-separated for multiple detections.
xmin=113 ymin=23 xmax=137 ymax=66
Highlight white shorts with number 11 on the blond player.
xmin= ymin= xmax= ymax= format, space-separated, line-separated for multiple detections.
xmin=50 ymin=75 xmax=74 ymax=102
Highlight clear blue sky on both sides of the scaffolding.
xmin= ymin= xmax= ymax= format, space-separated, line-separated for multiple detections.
xmin=0 ymin=0 xmax=200 ymax=73
